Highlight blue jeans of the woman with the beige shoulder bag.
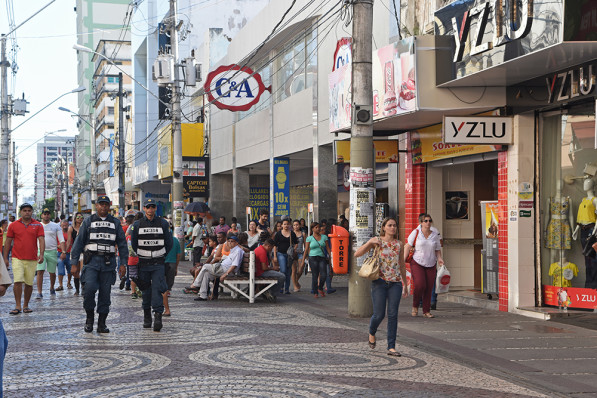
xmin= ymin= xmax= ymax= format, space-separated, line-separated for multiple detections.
xmin=369 ymin=279 xmax=402 ymax=350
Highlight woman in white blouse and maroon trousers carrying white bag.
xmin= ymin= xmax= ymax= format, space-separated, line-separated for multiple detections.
xmin=404 ymin=213 xmax=444 ymax=318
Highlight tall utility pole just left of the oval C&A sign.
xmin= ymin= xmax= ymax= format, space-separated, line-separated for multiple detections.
xmin=170 ymin=0 xmax=184 ymax=247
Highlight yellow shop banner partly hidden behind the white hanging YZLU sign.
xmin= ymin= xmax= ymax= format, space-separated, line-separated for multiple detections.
xmin=410 ymin=124 xmax=502 ymax=164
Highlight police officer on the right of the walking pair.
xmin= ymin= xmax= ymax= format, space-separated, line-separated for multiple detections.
xmin=131 ymin=199 xmax=172 ymax=332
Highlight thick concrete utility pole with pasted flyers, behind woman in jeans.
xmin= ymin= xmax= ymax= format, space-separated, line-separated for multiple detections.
xmin=348 ymin=0 xmax=375 ymax=317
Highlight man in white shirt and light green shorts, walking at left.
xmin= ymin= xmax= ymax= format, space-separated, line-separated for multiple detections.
xmin=35 ymin=208 xmax=66 ymax=300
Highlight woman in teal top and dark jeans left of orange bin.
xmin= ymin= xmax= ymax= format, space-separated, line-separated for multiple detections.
xmin=299 ymin=222 xmax=332 ymax=298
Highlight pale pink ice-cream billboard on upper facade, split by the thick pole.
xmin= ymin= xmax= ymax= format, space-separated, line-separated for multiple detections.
xmin=328 ymin=37 xmax=417 ymax=132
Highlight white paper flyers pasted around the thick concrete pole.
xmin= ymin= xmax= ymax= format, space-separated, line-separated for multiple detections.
xmin=350 ymin=167 xmax=375 ymax=267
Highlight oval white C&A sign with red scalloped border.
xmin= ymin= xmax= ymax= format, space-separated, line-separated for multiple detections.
xmin=204 ymin=65 xmax=271 ymax=112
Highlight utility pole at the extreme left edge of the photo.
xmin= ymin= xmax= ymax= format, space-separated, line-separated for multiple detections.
xmin=0 ymin=35 xmax=10 ymax=215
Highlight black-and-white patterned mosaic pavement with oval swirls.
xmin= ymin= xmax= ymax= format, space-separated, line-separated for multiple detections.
xmin=0 ymin=275 xmax=543 ymax=398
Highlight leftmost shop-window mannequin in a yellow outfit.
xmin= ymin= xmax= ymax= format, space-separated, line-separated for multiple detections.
xmin=545 ymin=180 xmax=574 ymax=250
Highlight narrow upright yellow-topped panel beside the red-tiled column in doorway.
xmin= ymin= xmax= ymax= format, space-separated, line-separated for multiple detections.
xmin=481 ymin=201 xmax=499 ymax=294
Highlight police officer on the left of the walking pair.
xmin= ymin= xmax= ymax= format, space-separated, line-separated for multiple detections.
xmin=71 ymin=195 xmax=128 ymax=333
